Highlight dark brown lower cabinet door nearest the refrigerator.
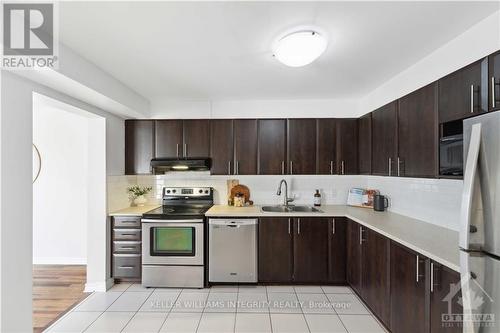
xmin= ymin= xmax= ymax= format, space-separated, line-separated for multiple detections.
xmin=429 ymin=261 xmax=463 ymax=333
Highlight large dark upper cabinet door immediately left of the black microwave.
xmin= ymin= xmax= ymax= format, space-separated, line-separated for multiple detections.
xmin=395 ymin=83 xmax=438 ymax=177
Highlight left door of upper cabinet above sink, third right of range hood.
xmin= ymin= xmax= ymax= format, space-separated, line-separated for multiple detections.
xmin=258 ymin=119 xmax=287 ymax=175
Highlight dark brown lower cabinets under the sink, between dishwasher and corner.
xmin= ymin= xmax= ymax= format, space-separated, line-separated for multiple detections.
xmin=259 ymin=217 xmax=336 ymax=283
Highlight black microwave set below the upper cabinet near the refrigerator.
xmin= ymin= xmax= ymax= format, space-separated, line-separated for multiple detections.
xmin=439 ymin=134 xmax=464 ymax=176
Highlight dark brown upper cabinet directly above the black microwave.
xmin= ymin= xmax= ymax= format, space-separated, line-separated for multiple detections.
xmin=439 ymin=58 xmax=488 ymax=123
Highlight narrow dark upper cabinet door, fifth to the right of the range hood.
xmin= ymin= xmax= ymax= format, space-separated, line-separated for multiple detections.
xmin=317 ymin=119 xmax=337 ymax=175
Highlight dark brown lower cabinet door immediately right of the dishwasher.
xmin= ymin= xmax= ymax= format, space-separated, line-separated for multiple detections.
xmin=259 ymin=217 xmax=293 ymax=282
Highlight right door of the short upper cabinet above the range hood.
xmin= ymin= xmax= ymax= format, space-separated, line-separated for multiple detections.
xmin=182 ymin=119 xmax=210 ymax=158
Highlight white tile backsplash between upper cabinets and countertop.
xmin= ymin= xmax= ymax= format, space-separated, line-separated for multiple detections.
xmin=108 ymin=172 xmax=462 ymax=230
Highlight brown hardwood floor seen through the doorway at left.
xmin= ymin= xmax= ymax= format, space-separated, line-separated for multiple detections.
xmin=33 ymin=265 xmax=89 ymax=333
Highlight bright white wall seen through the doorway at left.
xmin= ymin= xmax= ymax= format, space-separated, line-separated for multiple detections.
xmin=33 ymin=100 xmax=89 ymax=264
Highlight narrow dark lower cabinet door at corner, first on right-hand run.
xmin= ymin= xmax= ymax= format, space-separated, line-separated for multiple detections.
xmin=347 ymin=221 xmax=362 ymax=295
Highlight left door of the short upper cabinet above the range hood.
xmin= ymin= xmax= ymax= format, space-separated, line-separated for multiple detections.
xmin=155 ymin=120 xmax=182 ymax=158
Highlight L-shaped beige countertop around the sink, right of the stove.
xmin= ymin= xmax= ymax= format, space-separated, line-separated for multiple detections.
xmin=205 ymin=205 xmax=460 ymax=272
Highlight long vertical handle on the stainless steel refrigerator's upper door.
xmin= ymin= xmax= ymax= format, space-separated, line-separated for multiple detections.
xmin=459 ymin=123 xmax=481 ymax=250
